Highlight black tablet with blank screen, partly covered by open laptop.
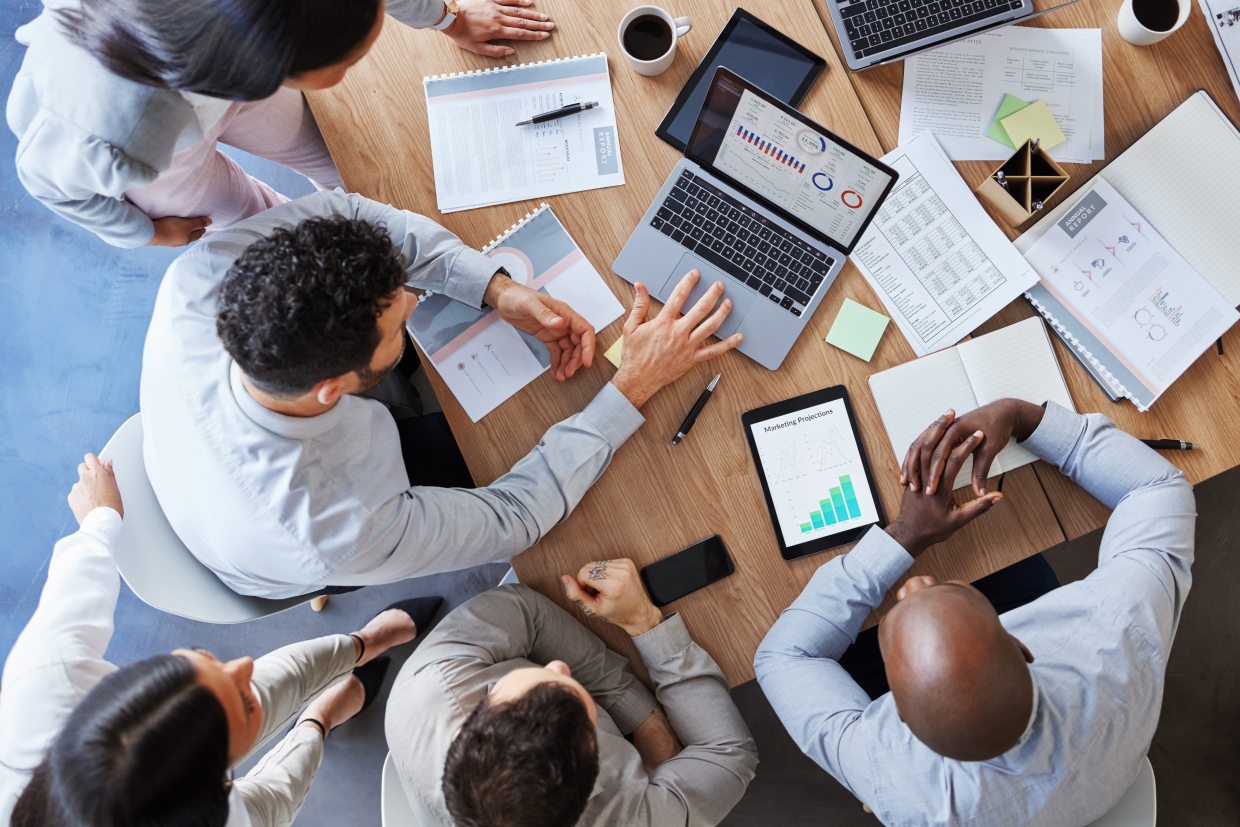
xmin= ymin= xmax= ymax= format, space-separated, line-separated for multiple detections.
xmin=655 ymin=9 xmax=827 ymax=151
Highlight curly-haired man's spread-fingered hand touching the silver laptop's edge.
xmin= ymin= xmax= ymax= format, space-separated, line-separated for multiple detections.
xmin=611 ymin=270 xmax=744 ymax=408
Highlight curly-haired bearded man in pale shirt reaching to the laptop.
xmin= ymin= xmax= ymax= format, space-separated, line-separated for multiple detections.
xmin=141 ymin=192 xmax=740 ymax=598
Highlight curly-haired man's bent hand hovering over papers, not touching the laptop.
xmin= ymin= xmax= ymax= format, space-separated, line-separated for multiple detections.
xmin=482 ymin=274 xmax=594 ymax=382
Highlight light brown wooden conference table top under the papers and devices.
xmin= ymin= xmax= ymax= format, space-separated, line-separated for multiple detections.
xmin=310 ymin=0 xmax=1240 ymax=686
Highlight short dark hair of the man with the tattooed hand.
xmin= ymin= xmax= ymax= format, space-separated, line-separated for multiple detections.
xmin=443 ymin=683 xmax=599 ymax=827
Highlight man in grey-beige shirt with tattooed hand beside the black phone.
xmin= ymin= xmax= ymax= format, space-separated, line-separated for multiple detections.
xmin=387 ymin=559 xmax=758 ymax=827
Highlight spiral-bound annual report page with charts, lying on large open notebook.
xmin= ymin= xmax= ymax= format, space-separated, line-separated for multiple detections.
xmin=1024 ymin=179 xmax=1240 ymax=410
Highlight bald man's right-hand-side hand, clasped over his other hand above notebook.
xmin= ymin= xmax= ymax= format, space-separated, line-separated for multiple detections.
xmin=900 ymin=399 xmax=1047 ymax=498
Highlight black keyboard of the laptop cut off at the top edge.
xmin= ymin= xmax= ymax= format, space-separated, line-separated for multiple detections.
xmin=837 ymin=0 xmax=1021 ymax=57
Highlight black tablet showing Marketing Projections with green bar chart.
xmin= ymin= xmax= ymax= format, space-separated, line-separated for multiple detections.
xmin=740 ymin=384 xmax=887 ymax=560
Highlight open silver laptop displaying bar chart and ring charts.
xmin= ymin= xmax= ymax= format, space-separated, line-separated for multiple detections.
xmin=611 ymin=67 xmax=899 ymax=371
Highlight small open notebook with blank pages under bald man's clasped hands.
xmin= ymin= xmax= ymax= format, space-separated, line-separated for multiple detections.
xmin=869 ymin=317 xmax=1076 ymax=490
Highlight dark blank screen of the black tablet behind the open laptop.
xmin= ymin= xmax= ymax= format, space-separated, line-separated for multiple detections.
xmin=663 ymin=17 xmax=822 ymax=149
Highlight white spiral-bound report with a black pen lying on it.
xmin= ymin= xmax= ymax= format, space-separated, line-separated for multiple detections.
xmin=422 ymin=55 xmax=624 ymax=213
